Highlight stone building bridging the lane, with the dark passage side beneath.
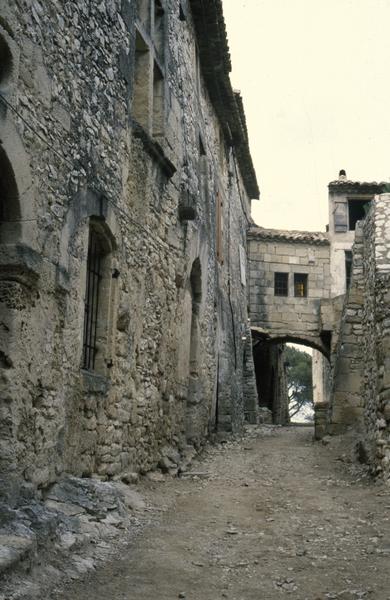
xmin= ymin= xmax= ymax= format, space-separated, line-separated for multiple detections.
xmin=248 ymin=226 xmax=331 ymax=424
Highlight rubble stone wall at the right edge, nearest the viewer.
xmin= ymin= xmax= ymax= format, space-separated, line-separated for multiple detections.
xmin=362 ymin=194 xmax=390 ymax=478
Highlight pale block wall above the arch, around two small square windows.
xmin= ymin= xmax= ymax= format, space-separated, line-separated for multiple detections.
xmin=249 ymin=227 xmax=330 ymax=348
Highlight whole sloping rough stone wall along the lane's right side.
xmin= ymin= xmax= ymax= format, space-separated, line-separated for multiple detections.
xmin=330 ymin=194 xmax=390 ymax=478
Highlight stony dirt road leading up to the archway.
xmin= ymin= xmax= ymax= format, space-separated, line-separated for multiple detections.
xmin=52 ymin=428 xmax=390 ymax=600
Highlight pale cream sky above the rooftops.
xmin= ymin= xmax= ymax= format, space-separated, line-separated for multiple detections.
xmin=223 ymin=0 xmax=390 ymax=231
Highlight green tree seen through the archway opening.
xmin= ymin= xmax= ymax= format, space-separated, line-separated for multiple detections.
xmin=285 ymin=346 xmax=313 ymax=418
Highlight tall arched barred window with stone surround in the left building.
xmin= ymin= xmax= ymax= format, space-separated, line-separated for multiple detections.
xmin=82 ymin=219 xmax=115 ymax=375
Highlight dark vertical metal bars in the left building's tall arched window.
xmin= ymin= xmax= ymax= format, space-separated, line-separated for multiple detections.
xmin=83 ymin=230 xmax=103 ymax=371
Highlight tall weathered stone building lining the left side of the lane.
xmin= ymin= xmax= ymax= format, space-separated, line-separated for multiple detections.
xmin=0 ymin=0 xmax=259 ymax=499
